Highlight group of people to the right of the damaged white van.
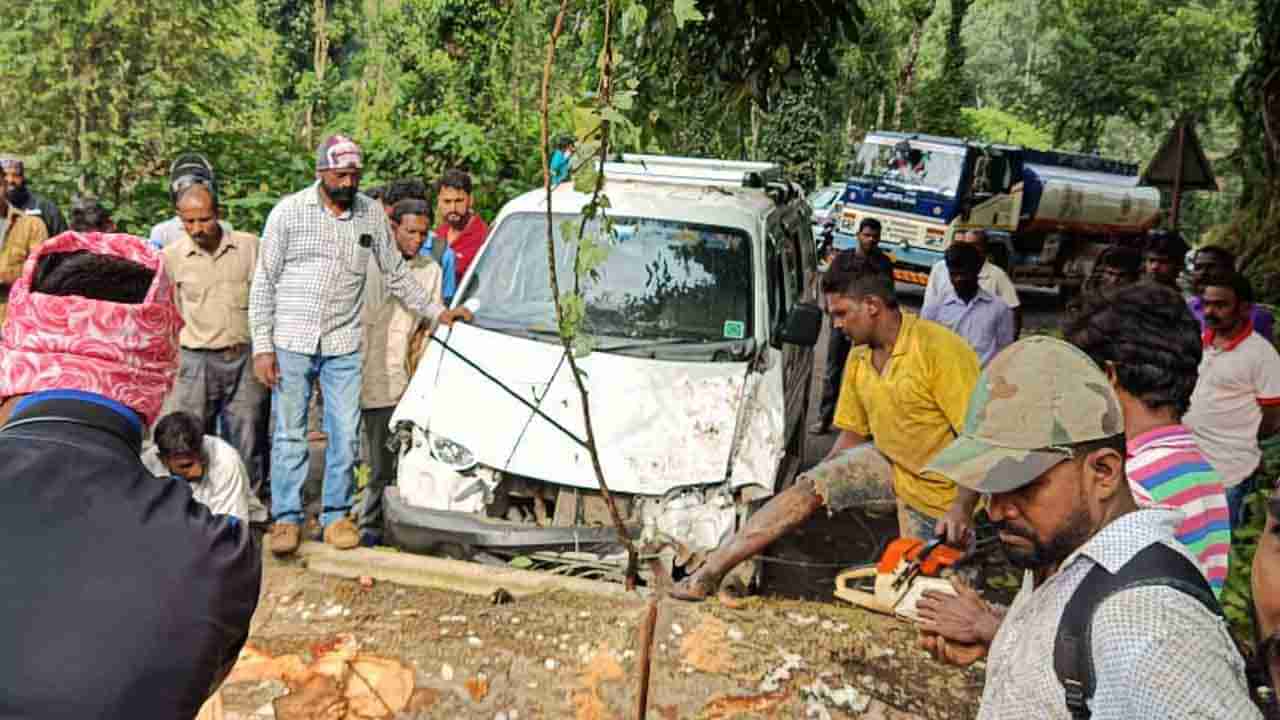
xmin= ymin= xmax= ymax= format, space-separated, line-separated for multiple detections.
xmin=672 ymin=219 xmax=1280 ymax=717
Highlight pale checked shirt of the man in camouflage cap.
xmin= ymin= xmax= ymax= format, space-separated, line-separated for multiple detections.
xmin=978 ymin=509 xmax=1262 ymax=720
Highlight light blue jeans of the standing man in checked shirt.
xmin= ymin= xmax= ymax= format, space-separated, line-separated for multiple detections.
xmin=271 ymin=350 xmax=362 ymax=527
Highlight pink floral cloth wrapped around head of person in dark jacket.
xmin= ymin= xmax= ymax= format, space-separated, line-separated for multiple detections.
xmin=0 ymin=232 xmax=182 ymax=425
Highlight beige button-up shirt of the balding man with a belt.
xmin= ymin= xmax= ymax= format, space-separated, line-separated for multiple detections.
xmin=164 ymin=232 xmax=257 ymax=350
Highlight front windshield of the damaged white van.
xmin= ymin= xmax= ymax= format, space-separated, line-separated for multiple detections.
xmin=463 ymin=213 xmax=753 ymax=350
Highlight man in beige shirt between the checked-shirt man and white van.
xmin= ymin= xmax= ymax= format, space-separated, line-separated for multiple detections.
xmin=360 ymin=199 xmax=443 ymax=547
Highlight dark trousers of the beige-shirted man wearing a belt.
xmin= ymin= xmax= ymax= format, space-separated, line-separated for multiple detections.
xmin=164 ymin=345 xmax=271 ymax=501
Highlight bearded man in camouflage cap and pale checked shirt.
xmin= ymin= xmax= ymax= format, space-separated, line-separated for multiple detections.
xmin=920 ymin=337 xmax=1258 ymax=719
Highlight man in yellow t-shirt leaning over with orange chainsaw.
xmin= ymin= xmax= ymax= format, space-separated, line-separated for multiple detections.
xmin=672 ymin=254 xmax=979 ymax=600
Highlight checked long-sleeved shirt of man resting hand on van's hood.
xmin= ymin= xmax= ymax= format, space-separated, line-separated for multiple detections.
xmin=248 ymin=182 xmax=444 ymax=355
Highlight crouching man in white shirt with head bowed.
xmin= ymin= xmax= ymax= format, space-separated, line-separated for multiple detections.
xmin=142 ymin=413 xmax=268 ymax=523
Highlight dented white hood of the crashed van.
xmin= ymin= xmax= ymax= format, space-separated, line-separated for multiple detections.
xmin=392 ymin=324 xmax=785 ymax=495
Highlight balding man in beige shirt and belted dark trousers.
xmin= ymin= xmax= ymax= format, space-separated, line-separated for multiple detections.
xmin=163 ymin=184 xmax=270 ymax=497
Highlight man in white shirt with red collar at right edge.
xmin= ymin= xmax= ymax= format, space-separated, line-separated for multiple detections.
xmin=1183 ymin=270 xmax=1280 ymax=528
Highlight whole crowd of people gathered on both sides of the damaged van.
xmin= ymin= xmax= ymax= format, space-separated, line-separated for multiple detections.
xmin=0 ymin=136 xmax=1280 ymax=719
